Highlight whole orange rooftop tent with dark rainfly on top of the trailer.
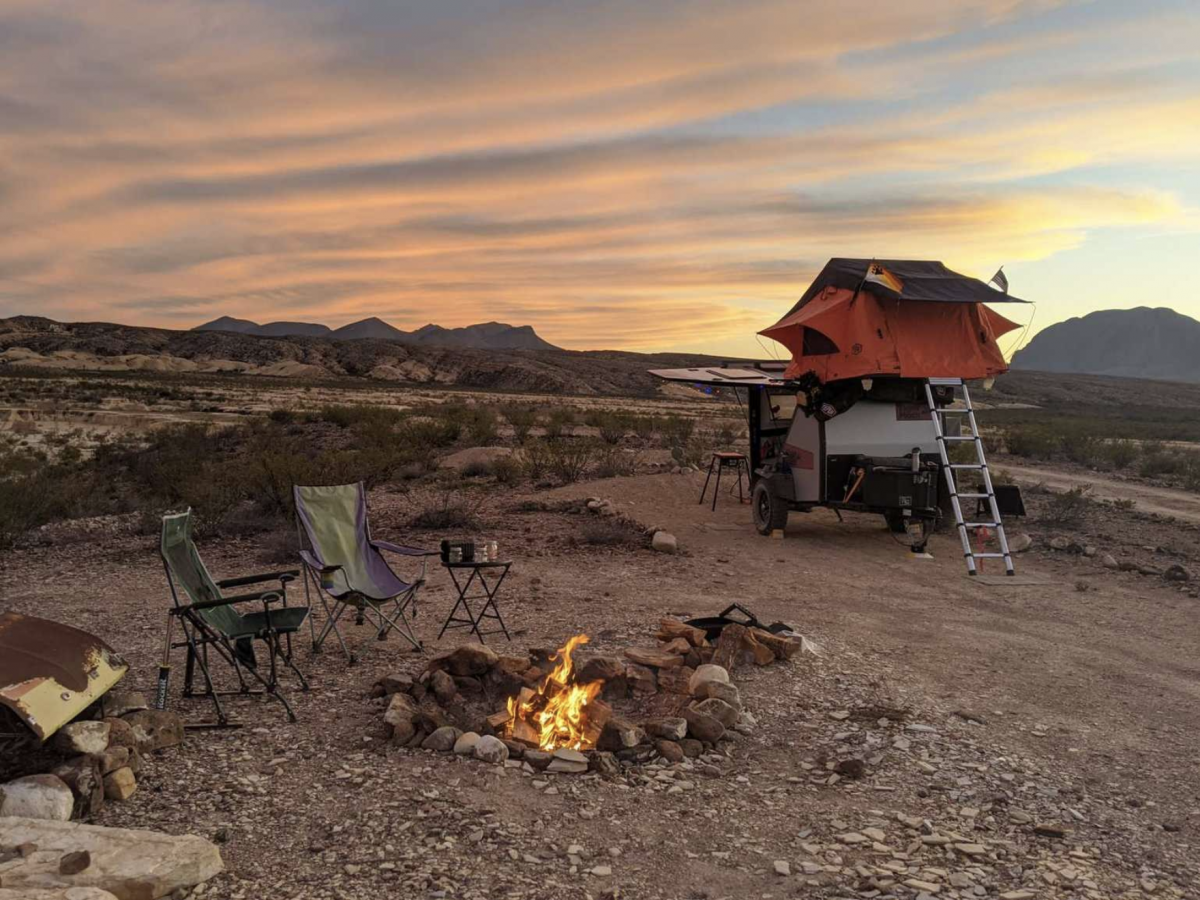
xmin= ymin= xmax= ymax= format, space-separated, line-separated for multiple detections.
xmin=760 ymin=259 xmax=1025 ymax=382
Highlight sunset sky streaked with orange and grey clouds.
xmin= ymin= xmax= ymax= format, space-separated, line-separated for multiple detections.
xmin=0 ymin=0 xmax=1200 ymax=358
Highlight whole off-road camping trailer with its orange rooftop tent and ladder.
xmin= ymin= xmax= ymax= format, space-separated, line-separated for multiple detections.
xmin=652 ymin=259 xmax=1025 ymax=575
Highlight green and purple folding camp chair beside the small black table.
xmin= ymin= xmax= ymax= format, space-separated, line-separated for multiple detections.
xmin=292 ymin=481 xmax=436 ymax=662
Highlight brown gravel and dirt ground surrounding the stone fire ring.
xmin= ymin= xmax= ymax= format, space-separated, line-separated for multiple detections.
xmin=0 ymin=474 xmax=1200 ymax=900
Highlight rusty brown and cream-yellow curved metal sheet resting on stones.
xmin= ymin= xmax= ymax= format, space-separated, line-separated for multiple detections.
xmin=0 ymin=612 xmax=128 ymax=740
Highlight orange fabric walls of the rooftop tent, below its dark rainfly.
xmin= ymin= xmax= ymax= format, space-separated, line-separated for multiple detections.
xmin=760 ymin=284 xmax=1020 ymax=382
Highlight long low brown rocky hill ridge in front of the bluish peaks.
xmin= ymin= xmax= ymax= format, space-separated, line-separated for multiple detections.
xmin=0 ymin=316 xmax=719 ymax=396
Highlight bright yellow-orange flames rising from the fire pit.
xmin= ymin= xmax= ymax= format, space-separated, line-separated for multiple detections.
xmin=506 ymin=635 xmax=604 ymax=750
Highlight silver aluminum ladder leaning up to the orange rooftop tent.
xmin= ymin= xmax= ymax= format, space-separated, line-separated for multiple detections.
xmin=925 ymin=378 xmax=1016 ymax=575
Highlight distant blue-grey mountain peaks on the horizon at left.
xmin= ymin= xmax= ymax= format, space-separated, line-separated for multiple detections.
xmin=192 ymin=316 xmax=558 ymax=350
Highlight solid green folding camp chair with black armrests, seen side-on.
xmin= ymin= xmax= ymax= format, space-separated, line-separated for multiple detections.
xmin=157 ymin=510 xmax=308 ymax=726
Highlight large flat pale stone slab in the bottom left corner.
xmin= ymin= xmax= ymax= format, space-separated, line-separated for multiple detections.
xmin=4 ymin=818 xmax=224 ymax=900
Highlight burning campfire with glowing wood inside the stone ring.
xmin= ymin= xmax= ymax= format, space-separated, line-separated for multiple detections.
xmin=504 ymin=635 xmax=611 ymax=751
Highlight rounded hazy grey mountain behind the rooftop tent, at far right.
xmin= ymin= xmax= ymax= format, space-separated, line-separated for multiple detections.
xmin=1012 ymin=306 xmax=1200 ymax=383
